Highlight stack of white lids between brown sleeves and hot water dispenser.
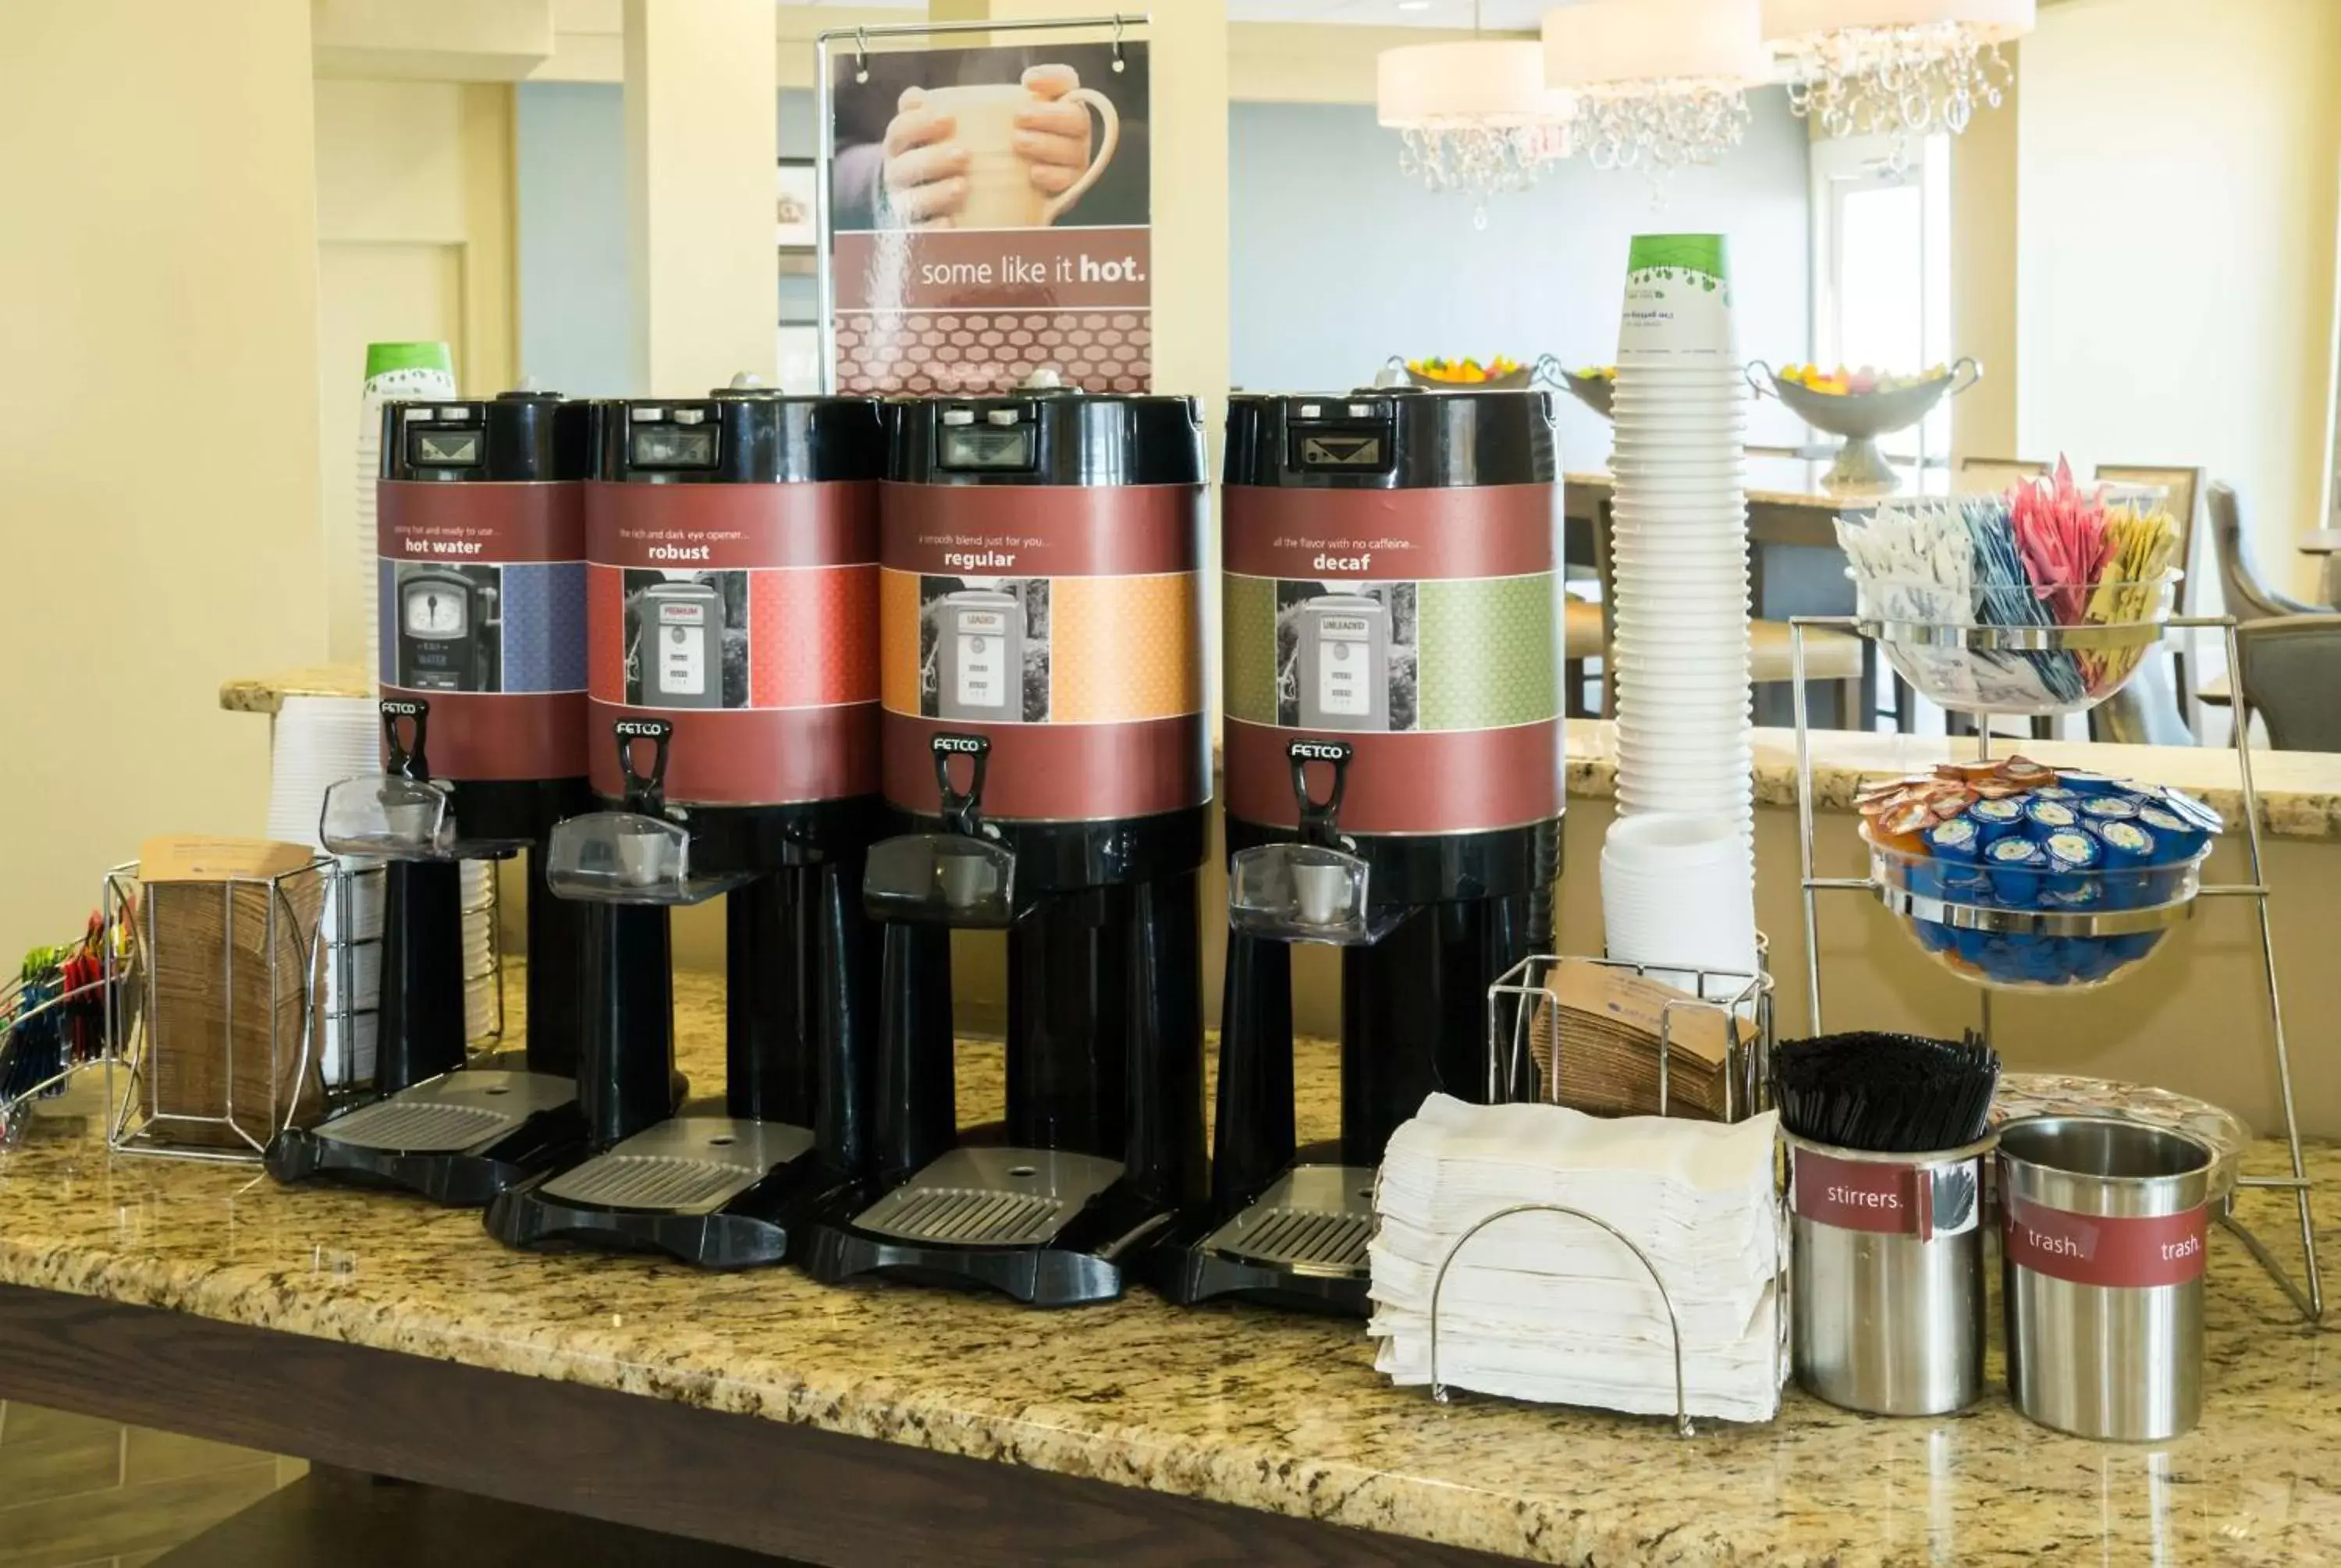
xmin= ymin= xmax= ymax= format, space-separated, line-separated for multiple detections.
xmin=269 ymin=697 xmax=384 ymax=1084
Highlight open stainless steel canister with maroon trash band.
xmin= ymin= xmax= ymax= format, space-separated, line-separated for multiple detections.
xmin=1999 ymin=1116 xmax=2215 ymax=1442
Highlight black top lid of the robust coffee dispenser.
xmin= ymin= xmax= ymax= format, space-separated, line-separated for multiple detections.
xmin=595 ymin=377 xmax=885 ymax=484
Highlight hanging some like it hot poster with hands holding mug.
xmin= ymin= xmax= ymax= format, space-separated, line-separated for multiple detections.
xmin=826 ymin=42 xmax=1154 ymax=393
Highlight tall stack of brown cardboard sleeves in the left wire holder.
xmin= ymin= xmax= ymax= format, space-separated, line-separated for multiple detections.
xmin=136 ymin=838 xmax=325 ymax=1149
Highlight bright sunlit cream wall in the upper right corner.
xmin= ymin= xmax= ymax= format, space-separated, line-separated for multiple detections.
xmin=2016 ymin=0 xmax=2341 ymax=590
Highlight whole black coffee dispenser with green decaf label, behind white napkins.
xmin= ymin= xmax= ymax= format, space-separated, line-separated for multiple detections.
xmin=1149 ymin=388 xmax=1561 ymax=1315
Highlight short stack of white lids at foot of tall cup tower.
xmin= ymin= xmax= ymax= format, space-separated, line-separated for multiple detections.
xmin=1601 ymin=812 xmax=1756 ymax=999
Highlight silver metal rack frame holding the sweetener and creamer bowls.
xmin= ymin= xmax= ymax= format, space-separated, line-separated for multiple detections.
xmin=1789 ymin=615 xmax=2325 ymax=1322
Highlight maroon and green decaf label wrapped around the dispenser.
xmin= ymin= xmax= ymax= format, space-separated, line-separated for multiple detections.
xmin=1222 ymin=484 xmax=1561 ymax=833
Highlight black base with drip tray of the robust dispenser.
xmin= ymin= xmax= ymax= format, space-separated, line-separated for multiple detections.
xmin=487 ymin=1114 xmax=847 ymax=1271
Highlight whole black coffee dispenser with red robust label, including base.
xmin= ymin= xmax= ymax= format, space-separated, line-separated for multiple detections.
xmin=487 ymin=384 xmax=885 ymax=1268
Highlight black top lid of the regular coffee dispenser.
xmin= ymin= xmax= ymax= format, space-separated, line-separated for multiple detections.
xmin=887 ymin=370 xmax=1208 ymax=484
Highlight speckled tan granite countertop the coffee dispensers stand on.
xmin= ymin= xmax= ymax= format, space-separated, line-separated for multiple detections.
xmin=0 ymin=976 xmax=2341 ymax=1568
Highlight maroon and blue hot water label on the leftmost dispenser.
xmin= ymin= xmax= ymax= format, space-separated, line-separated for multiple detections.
xmin=375 ymin=480 xmax=588 ymax=782
